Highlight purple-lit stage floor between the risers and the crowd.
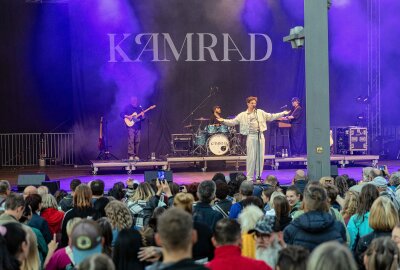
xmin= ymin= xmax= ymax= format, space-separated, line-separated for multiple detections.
xmin=0 ymin=160 xmax=400 ymax=190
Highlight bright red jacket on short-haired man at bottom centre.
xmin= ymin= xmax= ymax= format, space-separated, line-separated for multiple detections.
xmin=206 ymin=245 xmax=272 ymax=270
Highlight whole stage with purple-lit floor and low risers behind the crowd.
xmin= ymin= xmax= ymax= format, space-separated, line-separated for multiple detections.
xmin=0 ymin=155 xmax=392 ymax=191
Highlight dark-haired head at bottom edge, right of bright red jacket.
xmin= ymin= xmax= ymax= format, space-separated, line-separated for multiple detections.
xmin=275 ymin=246 xmax=310 ymax=270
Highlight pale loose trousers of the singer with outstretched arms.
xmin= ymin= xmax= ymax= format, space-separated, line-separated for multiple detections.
xmin=246 ymin=132 xmax=265 ymax=181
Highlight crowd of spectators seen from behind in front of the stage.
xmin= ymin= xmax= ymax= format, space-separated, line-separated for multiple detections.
xmin=0 ymin=167 xmax=400 ymax=270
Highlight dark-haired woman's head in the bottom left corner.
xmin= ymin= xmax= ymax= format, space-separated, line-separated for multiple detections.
xmin=0 ymin=223 xmax=29 ymax=270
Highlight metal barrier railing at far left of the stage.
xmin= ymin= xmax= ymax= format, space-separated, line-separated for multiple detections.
xmin=0 ymin=133 xmax=75 ymax=166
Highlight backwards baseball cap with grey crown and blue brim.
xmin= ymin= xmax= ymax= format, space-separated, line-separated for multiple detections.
xmin=71 ymin=219 xmax=102 ymax=265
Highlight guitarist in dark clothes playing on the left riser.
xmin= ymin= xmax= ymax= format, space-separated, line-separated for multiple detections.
xmin=120 ymin=96 xmax=144 ymax=160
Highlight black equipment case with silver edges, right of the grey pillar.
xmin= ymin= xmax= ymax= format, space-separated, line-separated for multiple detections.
xmin=336 ymin=126 xmax=368 ymax=155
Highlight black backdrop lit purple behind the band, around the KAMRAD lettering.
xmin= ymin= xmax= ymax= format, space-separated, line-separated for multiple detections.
xmin=0 ymin=0 xmax=396 ymax=163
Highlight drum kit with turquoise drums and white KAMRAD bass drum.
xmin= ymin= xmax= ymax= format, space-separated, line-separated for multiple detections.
xmin=185 ymin=117 xmax=246 ymax=156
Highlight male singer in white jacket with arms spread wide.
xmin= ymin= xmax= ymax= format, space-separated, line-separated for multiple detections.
xmin=218 ymin=96 xmax=289 ymax=181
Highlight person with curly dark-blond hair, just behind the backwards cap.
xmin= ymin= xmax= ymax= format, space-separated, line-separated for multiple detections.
xmin=105 ymin=200 xmax=133 ymax=246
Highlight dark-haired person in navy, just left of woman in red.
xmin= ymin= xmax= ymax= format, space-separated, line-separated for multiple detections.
xmin=25 ymin=194 xmax=53 ymax=244
